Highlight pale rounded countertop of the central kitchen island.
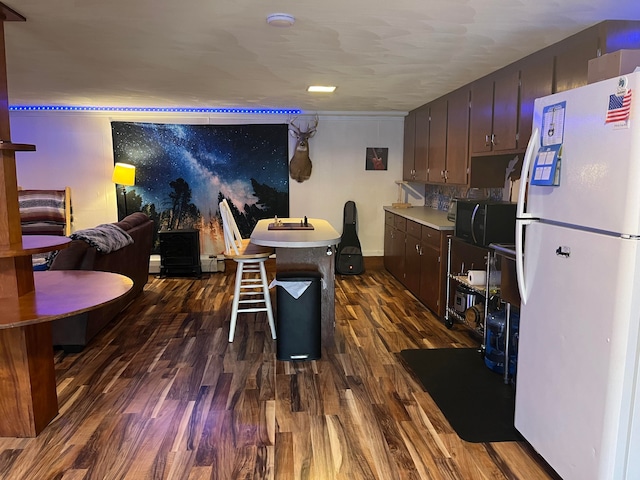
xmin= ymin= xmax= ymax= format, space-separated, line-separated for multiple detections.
xmin=251 ymin=218 xmax=340 ymax=248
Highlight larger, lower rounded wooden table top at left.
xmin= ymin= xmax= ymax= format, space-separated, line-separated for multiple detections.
xmin=0 ymin=270 xmax=133 ymax=329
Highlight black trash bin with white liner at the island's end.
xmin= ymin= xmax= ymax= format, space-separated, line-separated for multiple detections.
xmin=276 ymin=272 xmax=322 ymax=360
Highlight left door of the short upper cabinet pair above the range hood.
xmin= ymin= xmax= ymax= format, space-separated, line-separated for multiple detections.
xmin=469 ymin=76 xmax=493 ymax=155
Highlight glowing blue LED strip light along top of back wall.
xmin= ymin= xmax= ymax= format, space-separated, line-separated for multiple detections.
xmin=9 ymin=105 xmax=302 ymax=115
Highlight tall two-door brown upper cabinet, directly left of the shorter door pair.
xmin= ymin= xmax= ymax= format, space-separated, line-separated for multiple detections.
xmin=428 ymin=87 xmax=469 ymax=185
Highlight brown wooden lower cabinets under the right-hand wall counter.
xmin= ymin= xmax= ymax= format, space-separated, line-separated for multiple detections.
xmin=384 ymin=212 xmax=447 ymax=317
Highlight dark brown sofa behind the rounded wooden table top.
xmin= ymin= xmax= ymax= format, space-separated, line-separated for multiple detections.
xmin=50 ymin=212 xmax=154 ymax=352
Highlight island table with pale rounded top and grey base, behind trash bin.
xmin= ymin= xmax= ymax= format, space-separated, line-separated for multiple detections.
xmin=251 ymin=217 xmax=340 ymax=346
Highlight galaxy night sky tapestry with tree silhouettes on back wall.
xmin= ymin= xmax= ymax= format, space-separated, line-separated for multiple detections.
xmin=111 ymin=122 xmax=289 ymax=254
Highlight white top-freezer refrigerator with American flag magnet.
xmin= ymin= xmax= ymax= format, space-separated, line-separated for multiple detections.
xmin=515 ymin=73 xmax=640 ymax=480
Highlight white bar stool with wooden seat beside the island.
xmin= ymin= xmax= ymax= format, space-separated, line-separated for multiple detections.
xmin=220 ymin=199 xmax=276 ymax=342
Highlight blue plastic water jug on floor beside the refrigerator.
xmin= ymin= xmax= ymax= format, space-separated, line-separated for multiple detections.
xmin=484 ymin=309 xmax=520 ymax=376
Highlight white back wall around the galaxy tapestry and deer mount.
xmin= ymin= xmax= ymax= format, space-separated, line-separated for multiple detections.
xmin=10 ymin=111 xmax=410 ymax=256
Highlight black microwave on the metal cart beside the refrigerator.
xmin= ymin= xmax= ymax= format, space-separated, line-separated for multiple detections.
xmin=455 ymin=199 xmax=516 ymax=247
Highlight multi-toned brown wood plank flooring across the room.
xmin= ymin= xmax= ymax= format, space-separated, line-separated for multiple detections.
xmin=0 ymin=262 xmax=556 ymax=480
